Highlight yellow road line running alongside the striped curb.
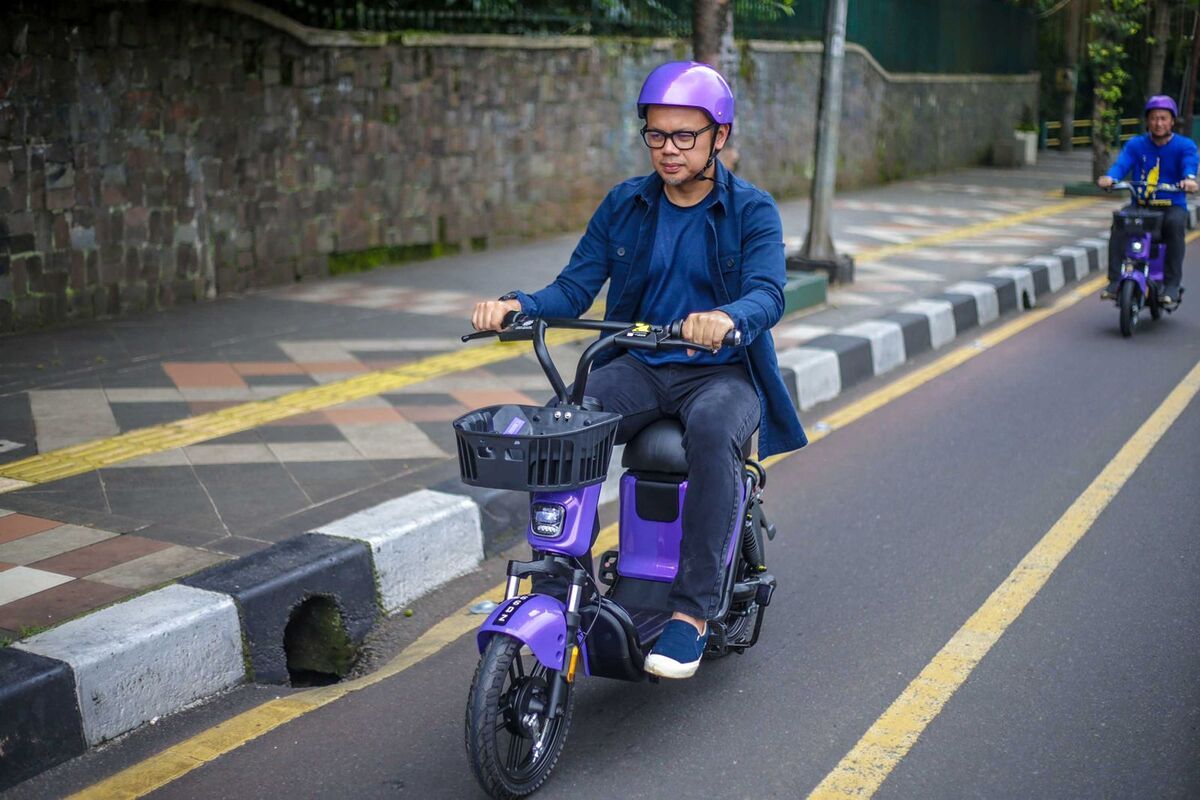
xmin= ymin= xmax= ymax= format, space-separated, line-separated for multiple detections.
xmin=72 ymin=271 xmax=1100 ymax=800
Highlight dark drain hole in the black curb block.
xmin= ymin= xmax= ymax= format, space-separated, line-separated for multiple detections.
xmin=283 ymin=595 xmax=358 ymax=686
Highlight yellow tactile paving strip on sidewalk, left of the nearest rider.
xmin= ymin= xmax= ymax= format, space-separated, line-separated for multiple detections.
xmin=0 ymin=330 xmax=595 ymax=493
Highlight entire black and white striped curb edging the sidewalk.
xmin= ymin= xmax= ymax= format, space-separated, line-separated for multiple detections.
xmin=0 ymin=210 xmax=1196 ymax=790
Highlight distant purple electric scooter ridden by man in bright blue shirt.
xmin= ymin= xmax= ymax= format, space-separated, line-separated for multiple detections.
xmin=1111 ymin=181 xmax=1183 ymax=337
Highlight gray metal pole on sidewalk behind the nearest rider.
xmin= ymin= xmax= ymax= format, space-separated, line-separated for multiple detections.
xmin=800 ymin=0 xmax=853 ymax=281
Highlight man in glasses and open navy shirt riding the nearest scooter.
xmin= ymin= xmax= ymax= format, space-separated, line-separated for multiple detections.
xmin=472 ymin=61 xmax=806 ymax=678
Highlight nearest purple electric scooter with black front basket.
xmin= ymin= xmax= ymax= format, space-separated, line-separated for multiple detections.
xmin=454 ymin=313 xmax=775 ymax=799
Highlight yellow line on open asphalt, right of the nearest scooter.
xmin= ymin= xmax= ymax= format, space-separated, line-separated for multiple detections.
xmin=809 ymin=362 xmax=1200 ymax=800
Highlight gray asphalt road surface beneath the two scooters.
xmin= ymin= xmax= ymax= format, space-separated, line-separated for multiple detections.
xmin=14 ymin=266 xmax=1200 ymax=800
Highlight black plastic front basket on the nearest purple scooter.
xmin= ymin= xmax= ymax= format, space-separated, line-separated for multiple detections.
xmin=454 ymin=404 xmax=620 ymax=492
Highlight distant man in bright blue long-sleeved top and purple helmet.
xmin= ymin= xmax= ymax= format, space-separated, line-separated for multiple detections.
xmin=1096 ymin=95 xmax=1198 ymax=306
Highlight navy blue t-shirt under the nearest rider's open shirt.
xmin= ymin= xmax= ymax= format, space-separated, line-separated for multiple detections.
xmin=631 ymin=194 xmax=742 ymax=365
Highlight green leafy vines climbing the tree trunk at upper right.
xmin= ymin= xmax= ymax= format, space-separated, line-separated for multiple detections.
xmin=1087 ymin=0 xmax=1147 ymax=142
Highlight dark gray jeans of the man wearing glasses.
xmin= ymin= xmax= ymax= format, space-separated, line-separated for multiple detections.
xmin=587 ymin=355 xmax=760 ymax=619
